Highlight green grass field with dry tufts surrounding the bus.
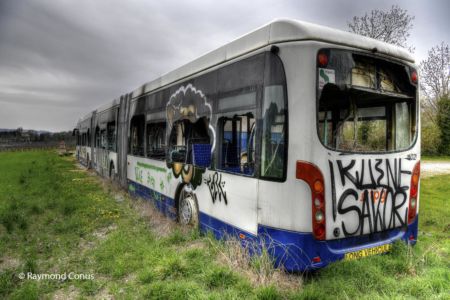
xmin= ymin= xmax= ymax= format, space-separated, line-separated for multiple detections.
xmin=0 ymin=151 xmax=450 ymax=299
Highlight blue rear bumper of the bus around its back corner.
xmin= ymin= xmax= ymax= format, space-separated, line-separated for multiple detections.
xmin=258 ymin=216 xmax=418 ymax=271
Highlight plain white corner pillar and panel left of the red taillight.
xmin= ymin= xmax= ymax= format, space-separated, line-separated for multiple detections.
xmin=258 ymin=42 xmax=316 ymax=233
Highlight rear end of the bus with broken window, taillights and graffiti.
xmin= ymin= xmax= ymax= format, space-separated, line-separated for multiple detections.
xmin=265 ymin=48 xmax=420 ymax=270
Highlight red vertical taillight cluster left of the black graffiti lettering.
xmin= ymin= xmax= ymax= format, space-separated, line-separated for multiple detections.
xmin=296 ymin=161 xmax=326 ymax=240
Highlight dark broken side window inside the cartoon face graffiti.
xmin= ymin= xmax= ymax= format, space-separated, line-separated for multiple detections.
xmin=169 ymin=117 xmax=210 ymax=164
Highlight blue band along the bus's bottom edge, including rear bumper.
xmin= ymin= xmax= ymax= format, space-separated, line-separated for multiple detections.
xmin=124 ymin=180 xmax=418 ymax=271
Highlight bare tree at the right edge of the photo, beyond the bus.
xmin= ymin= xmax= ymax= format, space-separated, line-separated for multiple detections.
xmin=420 ymin=42 xmax=450 ymax=120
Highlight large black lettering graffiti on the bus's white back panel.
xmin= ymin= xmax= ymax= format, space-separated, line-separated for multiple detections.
xmin=328 ymin=159 xmax=411 ymax=237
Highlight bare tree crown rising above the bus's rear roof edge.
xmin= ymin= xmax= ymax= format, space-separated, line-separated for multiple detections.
xmin=347 ymin=5 xmax=414 ymax=52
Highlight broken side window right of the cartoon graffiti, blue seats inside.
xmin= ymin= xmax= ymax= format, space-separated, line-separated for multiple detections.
xmin=219 ymin=112 xmax=256 ymax=175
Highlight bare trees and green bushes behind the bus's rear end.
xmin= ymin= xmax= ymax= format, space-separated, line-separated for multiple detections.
xmin=347 ymin=5 xmax=450 ymax=155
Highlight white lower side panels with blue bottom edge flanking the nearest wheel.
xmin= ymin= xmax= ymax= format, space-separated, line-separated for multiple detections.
xmin=127 ymin=155 xmax=258 ymax=236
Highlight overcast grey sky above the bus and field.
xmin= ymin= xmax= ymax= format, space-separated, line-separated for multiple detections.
xmin=0 ymin=0 xmax=450 ymax=131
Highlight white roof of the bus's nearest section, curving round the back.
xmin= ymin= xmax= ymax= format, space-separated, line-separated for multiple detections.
xmin=132 ymin=19 xmax=414 ymax=98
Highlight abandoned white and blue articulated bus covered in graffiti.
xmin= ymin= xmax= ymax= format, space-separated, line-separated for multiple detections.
xmin=77 ymin=20 xmax=420 ymax=271
